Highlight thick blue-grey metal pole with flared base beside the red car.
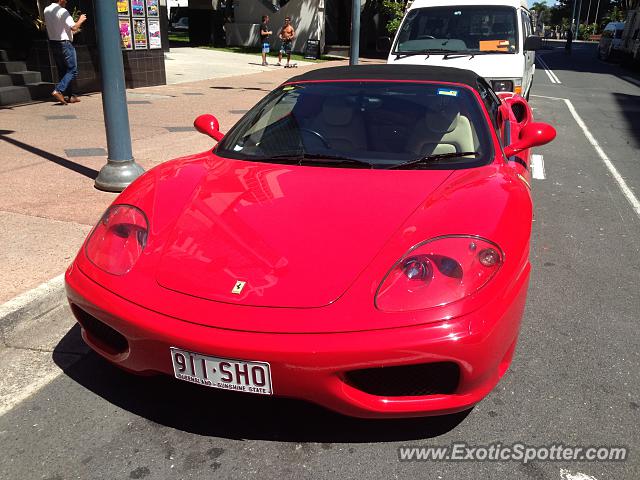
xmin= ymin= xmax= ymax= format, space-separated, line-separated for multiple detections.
xmin=94 ymin=0 xmax=144 ymax=192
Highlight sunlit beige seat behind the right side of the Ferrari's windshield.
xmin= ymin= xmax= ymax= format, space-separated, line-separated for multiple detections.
xmin=407 ymin=101 xmax=478 ymax=155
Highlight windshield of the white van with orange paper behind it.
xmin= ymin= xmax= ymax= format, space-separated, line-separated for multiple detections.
xmin=393 ymin=5 xmax=518 ymax=55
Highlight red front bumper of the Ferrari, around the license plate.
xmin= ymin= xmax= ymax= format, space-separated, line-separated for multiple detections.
xmin=66 ymin=266 xmax=529 ymax=418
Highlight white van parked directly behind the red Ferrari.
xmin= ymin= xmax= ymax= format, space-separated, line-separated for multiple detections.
xmin=387 ymin=0 xmax=542 ymax=98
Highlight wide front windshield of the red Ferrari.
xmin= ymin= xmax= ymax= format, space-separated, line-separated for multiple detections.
xmin=216 ymin=81 xmax=493 ymax=169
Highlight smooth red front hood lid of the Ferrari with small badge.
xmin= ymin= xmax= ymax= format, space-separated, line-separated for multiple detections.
xmin=156 ymin=160 xmax=451 ymax=308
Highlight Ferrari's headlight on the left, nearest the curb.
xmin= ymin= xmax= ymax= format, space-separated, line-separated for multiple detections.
xmin=85 ymin=205 xmax=149 ymax=275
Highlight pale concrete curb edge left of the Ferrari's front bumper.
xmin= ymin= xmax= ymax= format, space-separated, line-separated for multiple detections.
xmin=0 ymin=274 xmax=66 ymax=333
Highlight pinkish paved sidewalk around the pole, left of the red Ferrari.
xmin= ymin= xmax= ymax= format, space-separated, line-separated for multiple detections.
xmin=0 ymin=49 xmax=377 ymax=305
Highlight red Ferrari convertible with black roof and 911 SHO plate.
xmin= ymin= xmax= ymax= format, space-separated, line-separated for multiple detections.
xmin=66 ymin=65 xmax=555 ymax=417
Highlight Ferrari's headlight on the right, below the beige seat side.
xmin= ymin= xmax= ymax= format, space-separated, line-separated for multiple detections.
xmin=375 ymin=235 xmax=504 ymax=312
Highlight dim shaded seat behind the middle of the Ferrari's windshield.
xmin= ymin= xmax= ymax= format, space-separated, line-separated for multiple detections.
xmin=308 ymin=97 xmax=367 ymax=151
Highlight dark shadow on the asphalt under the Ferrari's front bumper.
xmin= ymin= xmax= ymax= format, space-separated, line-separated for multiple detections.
xmin=53 ymin=325 xmax=471 ymax=443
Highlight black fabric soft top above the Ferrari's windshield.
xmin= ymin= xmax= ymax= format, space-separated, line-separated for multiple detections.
xmin=285 ymin=65 xmax=480 ymax=90
